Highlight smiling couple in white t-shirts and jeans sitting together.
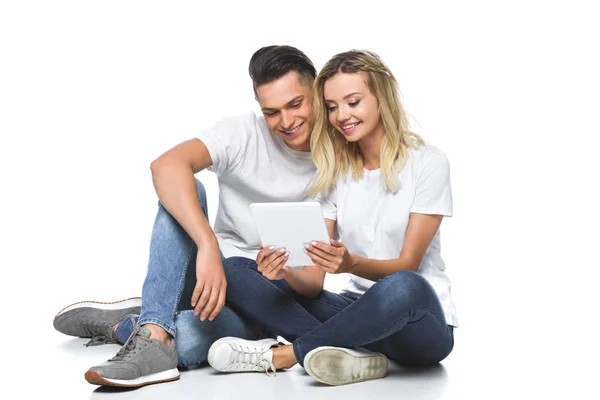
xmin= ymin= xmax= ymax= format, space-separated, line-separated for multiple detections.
xmin=54 ymin=46 xmax=457 ymax=387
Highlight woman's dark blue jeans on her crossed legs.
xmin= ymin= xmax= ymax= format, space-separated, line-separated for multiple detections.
xmin=224 ymin=257 xmax=454 ymax=366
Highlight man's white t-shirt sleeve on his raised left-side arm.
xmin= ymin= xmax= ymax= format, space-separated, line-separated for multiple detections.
xmin=197 ymin=115 xmax=255 ymax=177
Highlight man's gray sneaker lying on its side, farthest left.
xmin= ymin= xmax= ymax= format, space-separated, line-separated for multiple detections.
xmin=54 ymin=297 xmax=142 ymax=346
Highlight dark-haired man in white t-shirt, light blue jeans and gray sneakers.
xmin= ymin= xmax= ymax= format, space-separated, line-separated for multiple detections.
xmin=54 ymin=46 xmax=316 ymax=387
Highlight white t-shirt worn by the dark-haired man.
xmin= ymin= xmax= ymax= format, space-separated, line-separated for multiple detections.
xmin=198 ymin=113 xmax=316 ymax=259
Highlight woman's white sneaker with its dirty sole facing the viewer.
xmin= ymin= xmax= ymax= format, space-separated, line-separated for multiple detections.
xmin=304 ymin=346 xmax=387 ymax=385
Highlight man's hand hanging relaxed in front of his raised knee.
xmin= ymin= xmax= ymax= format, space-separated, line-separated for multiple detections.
xmin=192 ymin=241 xmax=227 ymax=321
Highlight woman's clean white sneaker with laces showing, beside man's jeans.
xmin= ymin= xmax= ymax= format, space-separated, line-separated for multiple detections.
xmin=208 ymin=337 xmax=279 ymax=376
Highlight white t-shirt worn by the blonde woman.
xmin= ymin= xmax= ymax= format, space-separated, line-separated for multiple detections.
xmin=321 ymin=144 xmax=458 ymax=326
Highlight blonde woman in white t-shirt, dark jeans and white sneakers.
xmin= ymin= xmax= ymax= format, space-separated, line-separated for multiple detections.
xmin=208 ymin=51 xmax=457 ymax=385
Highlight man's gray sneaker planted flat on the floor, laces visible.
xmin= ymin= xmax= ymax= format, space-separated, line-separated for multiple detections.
xmin=85 ymin=326 xmax=179 ymax=387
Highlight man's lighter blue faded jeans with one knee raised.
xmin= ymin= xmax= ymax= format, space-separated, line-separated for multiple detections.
xmin=115 ymin=180 xmax=264 ymax=367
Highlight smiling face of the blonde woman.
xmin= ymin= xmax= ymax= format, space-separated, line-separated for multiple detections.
xmin=323 ymin=72 xmax=383 ymax=142
